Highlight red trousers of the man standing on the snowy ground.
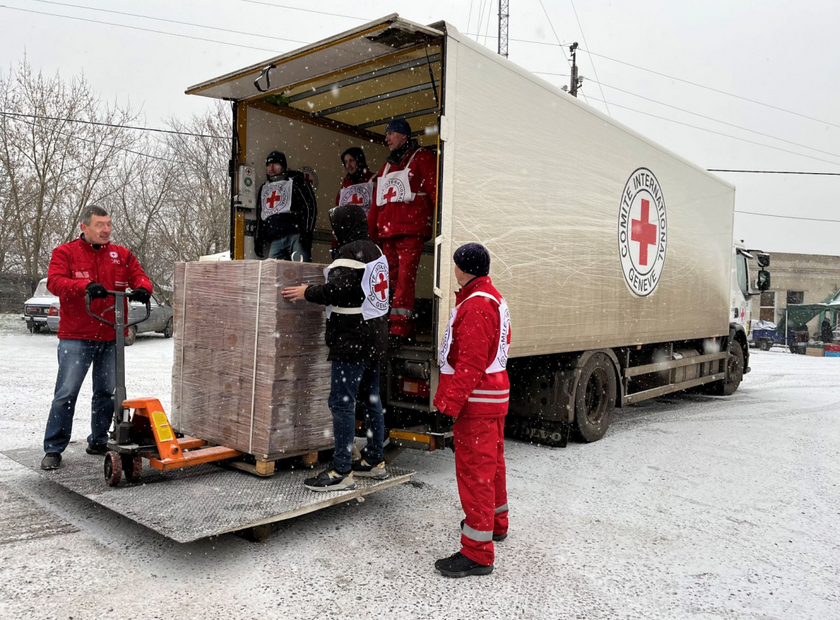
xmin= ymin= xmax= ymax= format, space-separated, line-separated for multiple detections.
xmin=452 ymin=416 xmax=508 ymax=566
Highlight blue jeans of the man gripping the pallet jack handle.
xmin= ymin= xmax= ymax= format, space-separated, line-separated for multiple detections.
xmin=44 ymin=340 xmax=117 ymax=452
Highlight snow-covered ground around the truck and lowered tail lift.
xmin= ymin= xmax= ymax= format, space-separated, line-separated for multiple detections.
xmin=0 ymin=315 xmax=840 ymax=620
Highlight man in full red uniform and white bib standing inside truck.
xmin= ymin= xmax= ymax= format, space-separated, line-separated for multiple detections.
xmin=368 ymin=119 xmax=437 ymax=346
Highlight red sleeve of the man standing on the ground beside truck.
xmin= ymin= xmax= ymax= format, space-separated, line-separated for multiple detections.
xmin=434 ymin=300 xmax=499 ymax=417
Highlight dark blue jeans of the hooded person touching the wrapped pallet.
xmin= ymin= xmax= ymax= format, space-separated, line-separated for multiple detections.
xmin=328 ymin=361 xmax=385 ymax=474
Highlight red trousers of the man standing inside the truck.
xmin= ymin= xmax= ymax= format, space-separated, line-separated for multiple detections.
xmin=382 ymin=235 xmax=423 ymax=338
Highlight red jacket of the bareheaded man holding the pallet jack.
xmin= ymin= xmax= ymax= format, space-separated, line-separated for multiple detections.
xmin=47 ymin=237 xmax=152 ymax=341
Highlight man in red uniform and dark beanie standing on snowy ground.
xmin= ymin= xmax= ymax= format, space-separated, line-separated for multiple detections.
xmin=434 ymin=243 xmax=510 ymax=577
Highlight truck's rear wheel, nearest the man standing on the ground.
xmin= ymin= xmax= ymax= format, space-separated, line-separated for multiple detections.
xmin=575 ymin=353 xmax=617 ymax=443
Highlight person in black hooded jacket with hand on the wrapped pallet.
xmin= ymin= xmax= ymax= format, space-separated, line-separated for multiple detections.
xmin=281 ymin=204 xmax=388 ymax=491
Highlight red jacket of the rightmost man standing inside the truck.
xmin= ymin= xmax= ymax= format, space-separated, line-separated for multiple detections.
xmin=368 ymin=148 xmax=437 ymax=243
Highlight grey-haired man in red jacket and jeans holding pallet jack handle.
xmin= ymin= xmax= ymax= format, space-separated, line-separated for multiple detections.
xmin=41 ymin=206 xmax=152 ymax=469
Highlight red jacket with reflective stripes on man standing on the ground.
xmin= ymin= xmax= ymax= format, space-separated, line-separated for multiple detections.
xmin=434 ymin=276 xmax=510 ymax=418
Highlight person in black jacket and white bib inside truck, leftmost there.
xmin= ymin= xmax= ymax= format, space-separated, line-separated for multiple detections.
xmin=254 ymin=151 xmax=318 ymax=263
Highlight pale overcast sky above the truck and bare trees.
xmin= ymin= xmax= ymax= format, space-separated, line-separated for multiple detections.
xmin=0 ymin=0 xmax=840 ymax=255
